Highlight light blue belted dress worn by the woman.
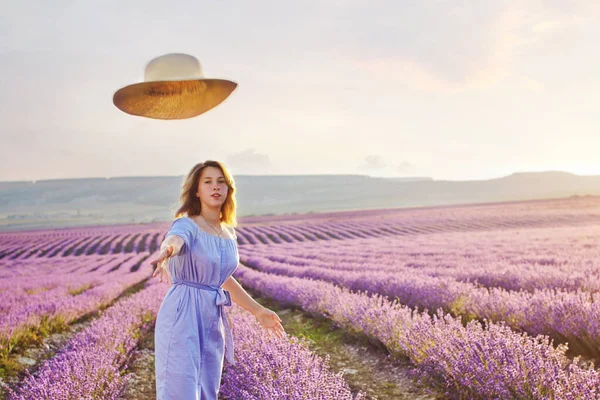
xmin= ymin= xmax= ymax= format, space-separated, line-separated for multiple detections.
xmin=154 ymin=217 xmax=240 ymax=400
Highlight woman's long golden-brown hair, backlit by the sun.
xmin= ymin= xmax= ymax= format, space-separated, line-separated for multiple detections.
xmin=175 ymin=160 xmax=237 ymax=227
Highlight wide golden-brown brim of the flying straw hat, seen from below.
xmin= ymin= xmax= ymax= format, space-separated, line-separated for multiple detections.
xmin=113 ymin=79 xmax=237 ymax=119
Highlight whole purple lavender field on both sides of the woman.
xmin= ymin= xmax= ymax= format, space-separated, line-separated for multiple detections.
xmin=0 ymin=196 xmax=600 ymax=399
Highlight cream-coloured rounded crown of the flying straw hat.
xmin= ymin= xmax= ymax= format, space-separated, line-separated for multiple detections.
xmin=144 ymin=53 xmax=204 ymax=82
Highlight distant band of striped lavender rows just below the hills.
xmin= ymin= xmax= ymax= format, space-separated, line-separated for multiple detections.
xmin=0 ymin=195 xmax=600 ymax=261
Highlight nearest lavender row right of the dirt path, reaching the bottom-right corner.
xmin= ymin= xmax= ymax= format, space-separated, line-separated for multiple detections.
xmin=236 ymin=266 xmax=600 ymax=400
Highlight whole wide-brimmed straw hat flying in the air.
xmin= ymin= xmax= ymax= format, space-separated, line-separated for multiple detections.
xmin=113 ymin=53 xmax=237 ymax=119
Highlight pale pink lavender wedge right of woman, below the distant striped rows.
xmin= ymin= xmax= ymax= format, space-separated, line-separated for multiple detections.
xmin=240 ymin=225 xmax=600 ymax=292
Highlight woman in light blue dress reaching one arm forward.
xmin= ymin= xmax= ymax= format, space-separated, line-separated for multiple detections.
xmin=151 ymin=160 xmax=284 ymax=400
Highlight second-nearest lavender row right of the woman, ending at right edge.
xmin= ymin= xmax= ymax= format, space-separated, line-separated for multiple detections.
xmin=240 ymin=241 xmax=600 ymax=355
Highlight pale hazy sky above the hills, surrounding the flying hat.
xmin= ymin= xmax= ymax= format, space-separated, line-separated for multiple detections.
xmin=0 ymin=0 xmax=600 ymax=181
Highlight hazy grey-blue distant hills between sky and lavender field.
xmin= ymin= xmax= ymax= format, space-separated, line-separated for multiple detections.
xmin=0 ymin=171 xmax=600 ymax=230
